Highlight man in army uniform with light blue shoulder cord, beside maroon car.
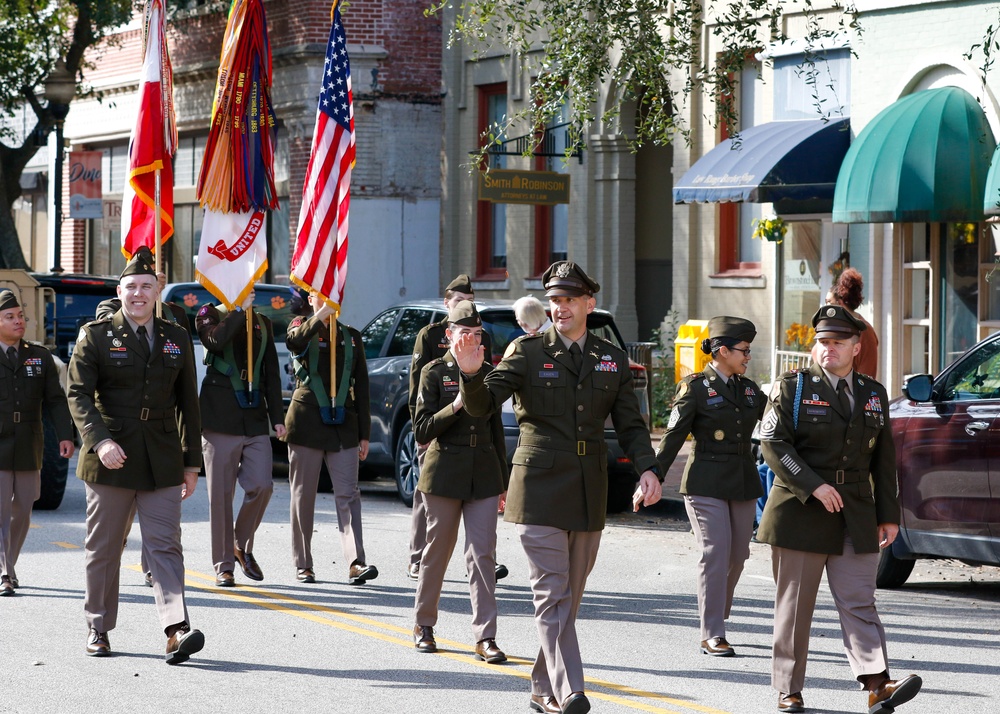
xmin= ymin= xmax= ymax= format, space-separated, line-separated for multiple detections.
xmin=757 ymin=305 xmax=921 ymax=714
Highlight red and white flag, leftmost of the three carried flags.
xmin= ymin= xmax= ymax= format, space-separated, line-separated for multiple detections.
xmin=122 ymin=0 xmax=177 ymax=258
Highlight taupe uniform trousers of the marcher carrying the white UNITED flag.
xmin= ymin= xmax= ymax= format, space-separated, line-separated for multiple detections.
xmin=201 ymin=430 xmax=274 ymax=574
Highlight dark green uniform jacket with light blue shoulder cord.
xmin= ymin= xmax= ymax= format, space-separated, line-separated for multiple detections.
xmin=757 ymin=362 xmax=899 ymax=555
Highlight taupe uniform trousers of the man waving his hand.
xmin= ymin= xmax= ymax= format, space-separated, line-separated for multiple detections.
xmin=517 ymin=524 xmax=601 ymax=702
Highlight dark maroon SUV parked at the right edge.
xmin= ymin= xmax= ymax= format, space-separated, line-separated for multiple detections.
xmin=876 ymin=333 xmax=1000 ymax=588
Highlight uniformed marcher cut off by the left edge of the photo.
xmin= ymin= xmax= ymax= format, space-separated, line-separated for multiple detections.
xmin=0 ymin=290 xmax=73 ymax=596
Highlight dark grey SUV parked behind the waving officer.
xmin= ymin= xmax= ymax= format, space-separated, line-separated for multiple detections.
xmin=361 ymin=300 xmax=649 ymax=512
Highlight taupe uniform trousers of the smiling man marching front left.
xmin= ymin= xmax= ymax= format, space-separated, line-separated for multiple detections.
xmin=83 ymin=483 xmax=190 ymax=632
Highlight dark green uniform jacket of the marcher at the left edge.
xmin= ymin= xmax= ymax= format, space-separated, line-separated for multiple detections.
xmin=0 ymin=340 xmax=73 ymax=471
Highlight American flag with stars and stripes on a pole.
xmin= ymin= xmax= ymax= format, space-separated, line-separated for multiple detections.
xmin=291 ymin=2 xmax=355 ymax=308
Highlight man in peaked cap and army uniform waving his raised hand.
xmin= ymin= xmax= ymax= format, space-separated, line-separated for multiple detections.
xmin=453 ymin=261 xmax=661 ymax=714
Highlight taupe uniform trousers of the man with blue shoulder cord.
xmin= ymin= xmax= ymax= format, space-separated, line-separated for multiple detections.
xmin=771 ymin=537 xmax=889 ymax=693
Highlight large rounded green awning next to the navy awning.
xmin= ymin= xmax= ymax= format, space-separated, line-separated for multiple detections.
xmin=833 ymin=87 xmax=996 ymax=223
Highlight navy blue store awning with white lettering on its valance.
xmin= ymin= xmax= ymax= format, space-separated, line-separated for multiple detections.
xmin=674 ymin=119 xmax=851 ymax=203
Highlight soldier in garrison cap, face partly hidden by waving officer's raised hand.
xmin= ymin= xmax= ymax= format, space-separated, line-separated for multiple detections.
xmin=413 ymin=300 xmax=507 ymax=664
